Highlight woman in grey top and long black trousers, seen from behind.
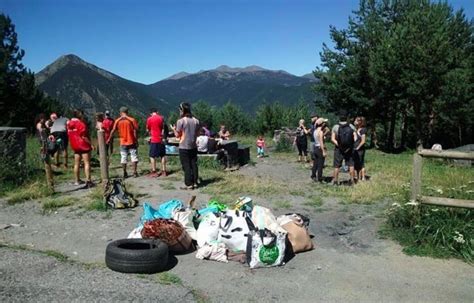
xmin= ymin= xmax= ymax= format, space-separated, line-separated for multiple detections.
xmin=171 ymin=102 xmax=200 ymax=190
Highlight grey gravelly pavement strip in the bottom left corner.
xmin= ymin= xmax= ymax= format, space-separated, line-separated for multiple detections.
xmin=0 ymin=248 xmax=195 ymax=302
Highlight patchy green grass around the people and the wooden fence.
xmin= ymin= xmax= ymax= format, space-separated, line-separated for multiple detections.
xmin=0 ymin=137 xmax=474 ymax=261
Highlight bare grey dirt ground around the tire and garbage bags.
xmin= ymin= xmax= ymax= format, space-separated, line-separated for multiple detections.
xmin=0 ymin=157 xmax=474 ymax=302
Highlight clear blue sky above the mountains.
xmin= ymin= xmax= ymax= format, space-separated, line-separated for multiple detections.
xmin=0 ymin=0 xmax=474 ymax=84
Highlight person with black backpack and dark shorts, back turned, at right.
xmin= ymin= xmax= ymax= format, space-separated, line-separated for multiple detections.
xmin=331 ymin=112 xmax=356 ymax=185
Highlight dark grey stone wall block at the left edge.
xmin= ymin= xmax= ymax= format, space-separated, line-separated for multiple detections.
xmin=0 ymin=127 xmax=26 ymax=183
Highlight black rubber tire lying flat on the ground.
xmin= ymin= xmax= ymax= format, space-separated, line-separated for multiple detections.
xmin=105 ymin=239 xmax=168 ymax=274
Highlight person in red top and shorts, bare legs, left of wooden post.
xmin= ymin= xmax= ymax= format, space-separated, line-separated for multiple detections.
xmin=67 ymin=109 xmax=93 ymax=187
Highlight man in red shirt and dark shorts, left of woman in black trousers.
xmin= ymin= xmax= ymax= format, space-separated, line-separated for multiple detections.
xmin=146 ymin=108 xmax=166 ymax=177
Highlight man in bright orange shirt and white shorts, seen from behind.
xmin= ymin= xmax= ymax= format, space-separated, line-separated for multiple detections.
xmin=107 ymin=106 xmax=138 ymax=178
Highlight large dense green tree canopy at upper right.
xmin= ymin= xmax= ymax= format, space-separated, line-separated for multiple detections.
xmin=315 ymin=0 xmax=474 ymax=149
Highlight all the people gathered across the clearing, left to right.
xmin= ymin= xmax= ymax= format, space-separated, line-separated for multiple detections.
xmin=35 ymin=102 xmax=367 ymax=190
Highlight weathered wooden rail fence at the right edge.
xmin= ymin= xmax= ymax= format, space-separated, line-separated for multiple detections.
xmin=411 ymin=149 xmax=474 ymax=208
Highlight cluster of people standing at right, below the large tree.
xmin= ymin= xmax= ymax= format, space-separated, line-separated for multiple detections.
xmin=294 ymin=112 xmax=367 ymax=185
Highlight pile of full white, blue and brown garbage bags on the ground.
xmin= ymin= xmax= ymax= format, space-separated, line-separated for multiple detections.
xmin=128 ymin=197 xmax=314 ymax=268
